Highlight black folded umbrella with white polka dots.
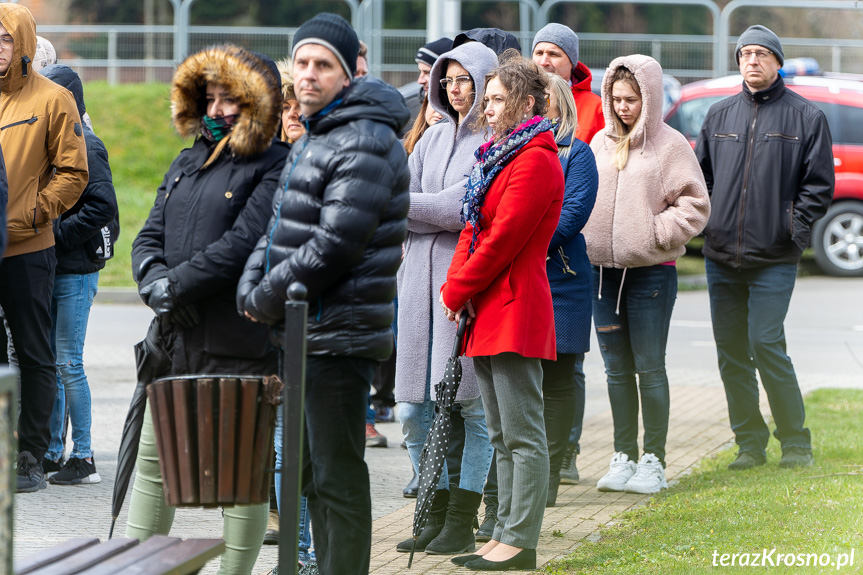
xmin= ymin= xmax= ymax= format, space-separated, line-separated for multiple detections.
xmin=408 ymin=318 xmax=468 ymax=569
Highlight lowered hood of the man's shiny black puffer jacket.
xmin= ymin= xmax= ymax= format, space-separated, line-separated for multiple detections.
xmin=310 ymin=76 xmax=411 ymax=137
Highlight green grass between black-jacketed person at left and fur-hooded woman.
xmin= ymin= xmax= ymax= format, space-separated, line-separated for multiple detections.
xmin=84 ymin=82 xmax=188 ymax=286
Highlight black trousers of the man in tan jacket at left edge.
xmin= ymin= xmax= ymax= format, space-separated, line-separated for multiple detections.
xmin=0 ymin=247 xmax=57 ymax=462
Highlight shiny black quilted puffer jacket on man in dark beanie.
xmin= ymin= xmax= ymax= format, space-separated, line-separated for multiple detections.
xmin=237 ymin=76 xmax=410 ymax=361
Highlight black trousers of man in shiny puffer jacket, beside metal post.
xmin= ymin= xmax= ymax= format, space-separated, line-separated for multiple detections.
xmin=303 ymin=356 xmax=377 ymax=575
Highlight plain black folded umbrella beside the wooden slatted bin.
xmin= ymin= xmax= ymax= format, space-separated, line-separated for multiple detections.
xmin=108 ymin=316 xmax=171 ymax=539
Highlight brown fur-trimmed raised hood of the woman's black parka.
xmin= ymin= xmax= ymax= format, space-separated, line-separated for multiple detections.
xmin=171 ymin=44 xmax=282 ymax=156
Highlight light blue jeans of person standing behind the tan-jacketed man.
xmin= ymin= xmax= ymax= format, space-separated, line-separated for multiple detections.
xmin=45 ymin=272 xmax=99 ymax=461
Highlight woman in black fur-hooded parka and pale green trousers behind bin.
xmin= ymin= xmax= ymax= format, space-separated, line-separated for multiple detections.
xmin=126 ymin=44 xmax=288 ymax=575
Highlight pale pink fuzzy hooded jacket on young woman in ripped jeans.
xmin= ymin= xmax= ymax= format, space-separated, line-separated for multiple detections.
xmin=584 ymin=54 xmax=710 ymax=268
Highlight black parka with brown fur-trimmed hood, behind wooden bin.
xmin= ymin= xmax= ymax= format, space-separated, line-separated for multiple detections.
xmin=132 ymin=44 xmax=288 ymax=375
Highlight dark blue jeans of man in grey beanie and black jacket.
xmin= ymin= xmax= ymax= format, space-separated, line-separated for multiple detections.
xmin=705 ymin=260 xmax=812 ymax=456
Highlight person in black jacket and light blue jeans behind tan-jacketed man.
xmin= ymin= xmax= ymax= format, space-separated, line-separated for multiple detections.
xmin=40 ymin=64 xmax=120 ymax=485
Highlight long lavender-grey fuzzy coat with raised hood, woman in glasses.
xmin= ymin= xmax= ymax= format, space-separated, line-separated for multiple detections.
xmin=395 ymin=42 xmax=497 ymax=403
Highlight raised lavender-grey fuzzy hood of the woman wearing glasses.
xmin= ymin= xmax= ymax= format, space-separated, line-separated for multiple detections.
xmin=429 ymin=42 xmax=497 ymax=129
